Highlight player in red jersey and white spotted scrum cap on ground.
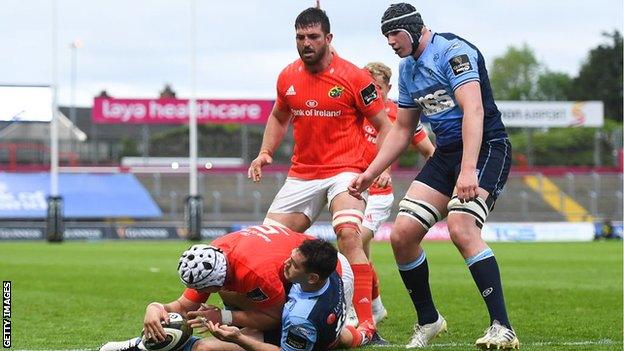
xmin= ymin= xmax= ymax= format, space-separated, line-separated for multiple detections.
xmin=100 ymin=226 xmax=380 ymax=351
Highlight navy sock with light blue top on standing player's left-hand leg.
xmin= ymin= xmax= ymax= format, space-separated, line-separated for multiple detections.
xmin=398 ymin=251 xmax=438 ymax=325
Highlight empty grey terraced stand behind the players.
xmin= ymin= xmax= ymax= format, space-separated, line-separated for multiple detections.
xmin=137 ymin=171 xmax=622 ymax=222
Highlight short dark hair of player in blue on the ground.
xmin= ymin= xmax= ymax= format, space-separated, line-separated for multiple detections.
xmin=299 ymin=239 xmax=338 ymax=279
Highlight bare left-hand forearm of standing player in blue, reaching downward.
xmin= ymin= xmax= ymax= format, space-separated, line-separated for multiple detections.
xmin=349 ymin=108 xmax=420 ymax=198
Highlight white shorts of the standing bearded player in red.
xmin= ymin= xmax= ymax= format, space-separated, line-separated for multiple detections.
xmin=268 ymin=172 xmax=367 ymax=222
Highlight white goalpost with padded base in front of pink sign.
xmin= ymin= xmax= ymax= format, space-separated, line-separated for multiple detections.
xmin=185 ymin=0 xmax=203 ymax=241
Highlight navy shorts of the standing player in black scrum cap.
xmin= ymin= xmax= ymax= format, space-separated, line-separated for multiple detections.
xmin=415 ymin=138 xmax=511 ymax=200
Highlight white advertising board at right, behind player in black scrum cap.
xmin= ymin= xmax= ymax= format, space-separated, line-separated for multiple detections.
xmin=496 ymin=101 xmax=604 ymax=128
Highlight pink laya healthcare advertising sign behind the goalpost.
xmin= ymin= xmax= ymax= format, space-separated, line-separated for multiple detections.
xmin=92 ymin=98 xmax=274 ymax=124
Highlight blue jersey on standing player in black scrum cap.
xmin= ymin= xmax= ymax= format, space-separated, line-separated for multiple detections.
xmin=399 ymin=33 xmax=507 ymax=147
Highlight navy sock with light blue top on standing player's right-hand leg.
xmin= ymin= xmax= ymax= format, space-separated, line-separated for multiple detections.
xmin=466 ymin=248 xmax=511 ymax=329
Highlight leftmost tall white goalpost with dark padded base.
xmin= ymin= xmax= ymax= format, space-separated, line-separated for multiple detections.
xmin=46 ymin=0 xmax=64 ymax=242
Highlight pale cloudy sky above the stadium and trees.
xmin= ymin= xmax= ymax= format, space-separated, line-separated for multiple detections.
xmin=0 ymin=0 xmax=624 ymax=106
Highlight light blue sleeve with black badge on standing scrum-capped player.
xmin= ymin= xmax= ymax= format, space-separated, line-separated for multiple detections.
xmin=440 ymin=39 xmax=479 ymax=91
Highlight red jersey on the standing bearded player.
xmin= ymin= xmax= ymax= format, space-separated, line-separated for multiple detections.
xmin=276 ymin=55 xmax=384 ymax=179
